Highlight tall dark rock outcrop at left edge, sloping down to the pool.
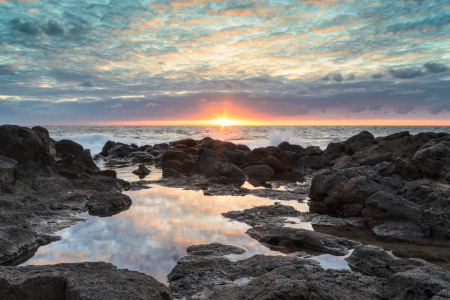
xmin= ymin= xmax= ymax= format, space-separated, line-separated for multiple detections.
xmin=0 ymin=125 xmax=135 ymax=265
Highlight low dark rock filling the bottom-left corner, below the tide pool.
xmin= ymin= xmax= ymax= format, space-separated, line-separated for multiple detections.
xmin=0 ymin=262 xmax=172 ymax=300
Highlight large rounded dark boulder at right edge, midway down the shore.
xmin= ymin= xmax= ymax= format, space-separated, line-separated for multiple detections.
xmin=310 ymin=167 xmax=450 ymax=238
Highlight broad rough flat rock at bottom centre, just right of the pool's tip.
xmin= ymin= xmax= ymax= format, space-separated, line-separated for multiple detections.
xmin=168 ymin=244 xmax=386 ymax=299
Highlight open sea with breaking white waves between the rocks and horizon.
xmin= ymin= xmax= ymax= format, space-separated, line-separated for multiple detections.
xmin=45 ymin=126 xmax=450 ymax=154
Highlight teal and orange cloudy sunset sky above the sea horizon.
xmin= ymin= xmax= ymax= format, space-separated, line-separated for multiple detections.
xmin=0 ymin=0 xmax=450 ymax=125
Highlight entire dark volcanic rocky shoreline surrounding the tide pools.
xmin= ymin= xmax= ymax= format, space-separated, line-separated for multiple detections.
xmin=0 ymin=125 xmax=450 ymax=299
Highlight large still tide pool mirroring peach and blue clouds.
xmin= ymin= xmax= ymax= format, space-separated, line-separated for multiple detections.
xmin=25 ymin=168 xmax=304 ymax=282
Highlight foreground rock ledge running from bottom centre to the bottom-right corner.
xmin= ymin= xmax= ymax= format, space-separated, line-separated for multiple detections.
xmin=169 ymin=241 xmax=450 ymax=299
